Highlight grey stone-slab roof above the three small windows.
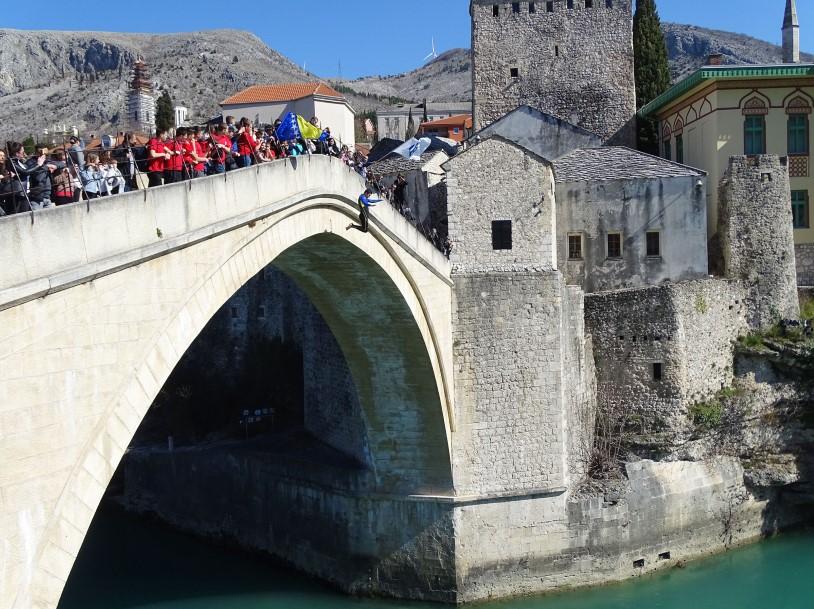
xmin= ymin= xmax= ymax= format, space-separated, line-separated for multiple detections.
xmin=553 ymin=146 xmax=706 ymax=182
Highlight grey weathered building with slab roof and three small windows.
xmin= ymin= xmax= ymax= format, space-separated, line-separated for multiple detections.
xmin=554 ymin=146 xmax=709 ymax=292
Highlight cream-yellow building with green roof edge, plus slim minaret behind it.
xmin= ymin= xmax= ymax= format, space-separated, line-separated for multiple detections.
xmin=640 ymin=0 xmax=814 ymax=285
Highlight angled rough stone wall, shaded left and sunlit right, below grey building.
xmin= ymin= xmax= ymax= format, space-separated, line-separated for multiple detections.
xmin=585 ymin=280 xmax=748 ymax=432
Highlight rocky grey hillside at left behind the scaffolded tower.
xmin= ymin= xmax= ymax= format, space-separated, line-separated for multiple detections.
xmin=0 ymin=30 xmax=382 ymax=138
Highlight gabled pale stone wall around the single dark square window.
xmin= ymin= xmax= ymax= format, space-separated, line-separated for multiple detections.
xmin=445 ymin=136 xmax=556 ymax=272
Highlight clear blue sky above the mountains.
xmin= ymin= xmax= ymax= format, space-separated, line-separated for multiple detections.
xmin=0 ymin=0 xmax=814 ymax=78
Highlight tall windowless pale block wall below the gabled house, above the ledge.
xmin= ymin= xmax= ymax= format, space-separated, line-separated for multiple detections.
xmin=453 ymin=272 xmax=565 ymax=495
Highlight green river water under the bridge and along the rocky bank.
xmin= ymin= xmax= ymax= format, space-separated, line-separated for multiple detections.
xmin=59 ymin=507 xmax=814 ymax=609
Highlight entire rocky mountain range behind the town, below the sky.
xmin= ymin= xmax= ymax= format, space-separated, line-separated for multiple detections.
xmin=0 ymin=23 xmax=814 ymax=138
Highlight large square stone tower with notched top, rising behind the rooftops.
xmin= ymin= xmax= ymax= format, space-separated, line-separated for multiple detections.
xmin=470 ymin=0 xmax=636 ymax=144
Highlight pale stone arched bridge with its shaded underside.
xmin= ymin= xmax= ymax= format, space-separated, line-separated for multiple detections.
xmin=0 ymin=156 xmax=453 ymax=609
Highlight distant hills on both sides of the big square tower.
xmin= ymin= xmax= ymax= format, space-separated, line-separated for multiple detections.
xmin=343 ymin=23 xmax=814 ymax=101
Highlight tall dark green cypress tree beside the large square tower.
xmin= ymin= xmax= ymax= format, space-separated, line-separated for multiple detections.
xmin=633 ymin=0 xmax=670 ymax=154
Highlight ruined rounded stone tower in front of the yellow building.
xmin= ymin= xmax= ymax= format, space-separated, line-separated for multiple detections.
xmin=718 ymin=155 xmax=800 ymax=329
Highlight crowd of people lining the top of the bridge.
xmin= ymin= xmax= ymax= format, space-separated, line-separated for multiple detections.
xmin=0 ymin=116 xmax=449 ymax=254
